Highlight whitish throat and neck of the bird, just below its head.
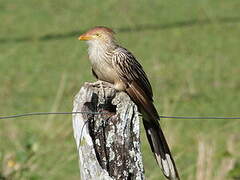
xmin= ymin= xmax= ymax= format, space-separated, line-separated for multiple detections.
xmin=88 ymin=40 xmax=117 ymax=64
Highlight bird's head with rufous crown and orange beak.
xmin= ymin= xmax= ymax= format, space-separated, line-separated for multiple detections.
xmin=78 ymin=26 xmax=115 ymax=44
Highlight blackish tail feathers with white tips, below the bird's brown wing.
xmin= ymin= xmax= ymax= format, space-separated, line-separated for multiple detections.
xmin=143 ymin=119 xmax=180 ymax=180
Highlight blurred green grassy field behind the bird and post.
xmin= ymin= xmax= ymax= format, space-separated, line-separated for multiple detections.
xmin=0 ymin=0 xmax=240 ymax=180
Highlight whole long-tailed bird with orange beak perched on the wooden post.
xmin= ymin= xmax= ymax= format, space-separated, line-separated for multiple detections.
xmin=78 ymin=26 xmax=180 ymax=180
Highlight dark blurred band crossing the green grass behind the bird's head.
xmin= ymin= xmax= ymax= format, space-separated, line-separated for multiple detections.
xmin=0 ymin=17 xmax=240 ymax=43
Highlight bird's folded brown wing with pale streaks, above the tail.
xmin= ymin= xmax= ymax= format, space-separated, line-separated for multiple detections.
xmin=112 ymin=47 xmax=158 ymax=119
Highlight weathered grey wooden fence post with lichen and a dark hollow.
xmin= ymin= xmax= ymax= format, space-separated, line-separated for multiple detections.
xmin=73 ymin=83 xmax=144 ymax=180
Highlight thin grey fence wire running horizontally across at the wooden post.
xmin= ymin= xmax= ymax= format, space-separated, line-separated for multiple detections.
xmin=0 ymin=111 xmax=240 ymax=120
